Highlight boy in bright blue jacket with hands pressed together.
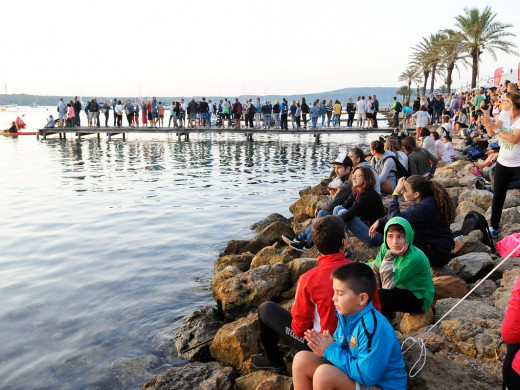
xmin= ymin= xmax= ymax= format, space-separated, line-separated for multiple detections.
xmin=293 ymin=263 xmax=407 ymax=390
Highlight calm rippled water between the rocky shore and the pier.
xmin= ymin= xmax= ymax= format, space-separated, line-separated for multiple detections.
xmin=0 ymin=108 xmax=377 ymax=389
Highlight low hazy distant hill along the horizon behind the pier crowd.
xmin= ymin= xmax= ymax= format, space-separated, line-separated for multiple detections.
xmin=8 ymin=87 xmax=399 ymax=107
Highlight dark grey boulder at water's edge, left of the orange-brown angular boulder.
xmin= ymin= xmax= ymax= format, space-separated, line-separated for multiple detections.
xmin=173 ymin=306 xmax=225 ymax=362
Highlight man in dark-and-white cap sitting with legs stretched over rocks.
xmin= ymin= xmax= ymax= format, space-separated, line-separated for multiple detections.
xmin=282 ymin=153 xmax=352 ymax=252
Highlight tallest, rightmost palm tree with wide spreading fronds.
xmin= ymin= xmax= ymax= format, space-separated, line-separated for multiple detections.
xmin=455 ymin=6 xmax=518 ymax=88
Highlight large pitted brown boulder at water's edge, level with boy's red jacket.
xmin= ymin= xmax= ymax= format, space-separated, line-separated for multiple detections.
xmin=213 ymin=263 xmax=289 ymax=319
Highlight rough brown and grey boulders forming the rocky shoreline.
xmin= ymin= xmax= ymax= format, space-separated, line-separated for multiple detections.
xmin=143 ymin=136 xmax=520 ymax=390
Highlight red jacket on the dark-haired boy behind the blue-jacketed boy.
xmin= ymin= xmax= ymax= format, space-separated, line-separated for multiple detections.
xmin=291 ymin=253 xmax=381 ymax=337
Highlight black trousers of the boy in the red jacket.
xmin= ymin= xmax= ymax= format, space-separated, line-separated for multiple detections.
xmin=258 ymin=301 xmax=309 ymax=362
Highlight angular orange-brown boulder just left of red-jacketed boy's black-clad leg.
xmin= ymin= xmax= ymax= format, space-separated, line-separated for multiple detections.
xmin=210 ymin=313 xmax=260 ymax=369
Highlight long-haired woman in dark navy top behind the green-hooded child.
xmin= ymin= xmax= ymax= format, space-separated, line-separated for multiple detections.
xmin=369 ymin=175 xmax=455 ymax=267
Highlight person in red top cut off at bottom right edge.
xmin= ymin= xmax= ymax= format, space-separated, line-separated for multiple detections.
xmin=502 ymin=278 xmax=520 ymax=389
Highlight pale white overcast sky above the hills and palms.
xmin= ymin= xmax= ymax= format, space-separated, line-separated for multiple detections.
xmin=4 ymin=0 xmax=520 ymax=97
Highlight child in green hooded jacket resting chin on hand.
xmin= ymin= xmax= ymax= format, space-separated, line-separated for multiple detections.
xmin=370 ymin=217 xmax=434 ymax=318
